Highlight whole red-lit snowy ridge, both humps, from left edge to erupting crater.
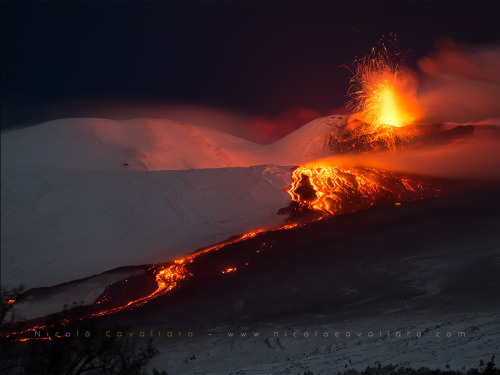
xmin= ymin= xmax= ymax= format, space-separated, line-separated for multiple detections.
xmin=2 ymin=116 xmax=346 ymax=171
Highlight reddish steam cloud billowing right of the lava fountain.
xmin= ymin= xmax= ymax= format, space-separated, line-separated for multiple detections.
xmin=417 ymin=39 xmax=500 ymax=125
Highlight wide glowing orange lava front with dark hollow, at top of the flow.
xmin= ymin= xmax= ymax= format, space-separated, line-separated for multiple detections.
xmin=288 ymin=165 xmax=440 ymax=215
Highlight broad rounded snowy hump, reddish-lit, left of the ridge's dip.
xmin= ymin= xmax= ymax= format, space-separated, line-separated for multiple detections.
xmin=2 ymin=119 xmax=259 ymax=170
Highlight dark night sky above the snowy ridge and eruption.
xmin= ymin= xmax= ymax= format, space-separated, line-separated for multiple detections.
xmin=1 ymin=1 xmax=500 ymax=128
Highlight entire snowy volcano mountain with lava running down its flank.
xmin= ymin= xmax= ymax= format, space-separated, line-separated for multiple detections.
xmin=2 ymin=116 xmax=500 ymax=373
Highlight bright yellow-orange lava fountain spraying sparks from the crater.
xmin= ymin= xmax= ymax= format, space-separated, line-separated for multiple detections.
xmin=349 ymin=38 xmax=420 ymax=130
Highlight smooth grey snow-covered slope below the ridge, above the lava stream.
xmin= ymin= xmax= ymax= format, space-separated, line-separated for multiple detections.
xmin=1 ymin=166 xmax=291 ymax=287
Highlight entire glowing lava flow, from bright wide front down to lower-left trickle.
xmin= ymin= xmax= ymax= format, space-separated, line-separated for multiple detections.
xmin=1 ymin=172 xmax=440 ymax=341
